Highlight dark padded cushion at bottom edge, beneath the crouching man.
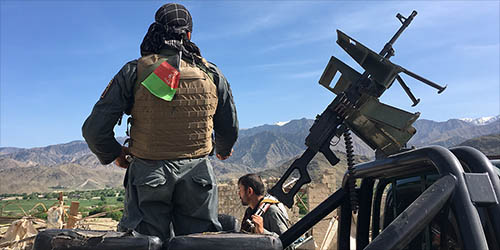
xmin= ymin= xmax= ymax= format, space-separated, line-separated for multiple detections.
xmin=168 ymin=233 xmax=283 ymax=250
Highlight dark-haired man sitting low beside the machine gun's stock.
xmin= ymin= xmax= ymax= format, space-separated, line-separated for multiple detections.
xmin=238 ymin=174 xmax=288 ymax=237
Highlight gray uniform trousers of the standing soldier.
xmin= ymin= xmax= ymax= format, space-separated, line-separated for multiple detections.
xmin=118 ymin=157 xmax=221 ymax=241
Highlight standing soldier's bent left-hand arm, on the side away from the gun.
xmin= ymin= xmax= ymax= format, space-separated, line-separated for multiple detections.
xmin=82 ymin=60 xmax=137 ymax=164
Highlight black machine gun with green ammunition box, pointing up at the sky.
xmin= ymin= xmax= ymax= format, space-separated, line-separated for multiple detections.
xmin=269 ymin=11 xmax=446 ymax=209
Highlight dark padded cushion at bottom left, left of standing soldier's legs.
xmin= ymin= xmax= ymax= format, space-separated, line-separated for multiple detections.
xmin=33 ymin=229 xmax=162 ymax=250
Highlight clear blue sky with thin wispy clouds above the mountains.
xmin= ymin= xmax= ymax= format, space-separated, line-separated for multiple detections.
xmin=0 ymin=0 xmax=500 ymax=148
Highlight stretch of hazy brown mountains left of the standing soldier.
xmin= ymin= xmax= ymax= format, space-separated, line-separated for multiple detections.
xmin=0 ymin=141 xmax=125 ymax=193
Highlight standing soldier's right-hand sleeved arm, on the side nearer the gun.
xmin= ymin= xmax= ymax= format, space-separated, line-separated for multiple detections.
xmin=209 ymin=63 xmax=238 ymax=157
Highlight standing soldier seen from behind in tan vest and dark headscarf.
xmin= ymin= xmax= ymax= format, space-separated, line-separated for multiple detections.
xmin=82 ymin=4 xmax=238 ymax=241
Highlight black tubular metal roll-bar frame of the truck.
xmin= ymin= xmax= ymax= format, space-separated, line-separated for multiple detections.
xmin=280 ymin=146 xmax=500 ymax=250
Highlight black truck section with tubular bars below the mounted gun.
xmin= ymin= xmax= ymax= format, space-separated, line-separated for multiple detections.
xmin=280 ymin=146 xmax=500 ymax=250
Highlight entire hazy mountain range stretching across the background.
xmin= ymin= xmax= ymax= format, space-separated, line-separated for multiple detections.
xmin=0 ymin=116 xmax=500 ymax=194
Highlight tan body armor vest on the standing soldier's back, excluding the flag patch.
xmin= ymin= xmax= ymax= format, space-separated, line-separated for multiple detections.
xmin=130 ymin=54 xmax=217 ymax=160
